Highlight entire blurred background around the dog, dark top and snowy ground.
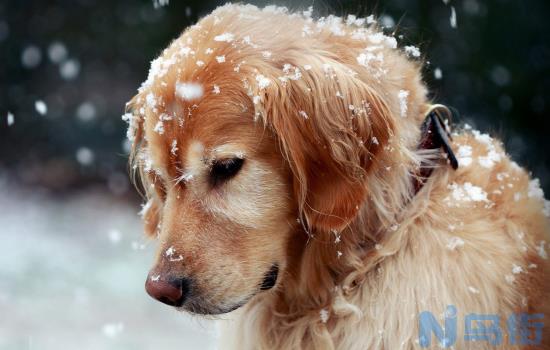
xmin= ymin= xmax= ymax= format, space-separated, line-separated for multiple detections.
xmin=0 ymin=0 xmax=550 ymax=350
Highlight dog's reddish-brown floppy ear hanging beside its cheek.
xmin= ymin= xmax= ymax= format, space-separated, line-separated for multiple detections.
xmin=250 ymin=59 xmax=393 ymax=230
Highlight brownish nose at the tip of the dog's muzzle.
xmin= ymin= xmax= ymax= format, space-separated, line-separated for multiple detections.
xmin=145 ymin=274 xmax=189 ymax=307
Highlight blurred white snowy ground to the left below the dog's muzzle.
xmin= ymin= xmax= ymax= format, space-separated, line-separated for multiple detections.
xmin=0 ymin=185 xmax=217 ymax=350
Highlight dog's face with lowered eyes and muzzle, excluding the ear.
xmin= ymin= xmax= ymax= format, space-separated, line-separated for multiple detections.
xmin=134 ymin=78 xmax=296 ymax=314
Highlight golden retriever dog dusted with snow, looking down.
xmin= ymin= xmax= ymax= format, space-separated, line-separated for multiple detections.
xmin=123 ymin=4 xmax=550 ymax=350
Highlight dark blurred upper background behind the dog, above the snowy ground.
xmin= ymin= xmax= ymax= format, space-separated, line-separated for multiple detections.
xmin=0 ymin=0 xmax=550 ymax=195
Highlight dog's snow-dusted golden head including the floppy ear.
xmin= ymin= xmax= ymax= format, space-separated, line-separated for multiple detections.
xmin=126 ymin=5 xmax=423 ymax=314
